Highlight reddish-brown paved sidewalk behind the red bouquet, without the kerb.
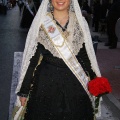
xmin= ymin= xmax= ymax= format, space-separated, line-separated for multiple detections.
xmin=91 ymin=32 xmax=120 ymax=106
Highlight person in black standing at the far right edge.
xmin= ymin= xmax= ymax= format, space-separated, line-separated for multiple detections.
xmin=105 ymin=0 xmax=120 ymax=49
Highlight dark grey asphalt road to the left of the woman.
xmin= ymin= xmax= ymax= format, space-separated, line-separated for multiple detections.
xmin=0 ymin=6 xmax=27 ymax=120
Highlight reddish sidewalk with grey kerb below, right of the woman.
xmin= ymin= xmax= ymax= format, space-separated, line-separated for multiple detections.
xmin=91 ymin=28 xmax=120 ymax=120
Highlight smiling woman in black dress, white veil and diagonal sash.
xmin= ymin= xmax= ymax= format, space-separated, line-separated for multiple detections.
xmin=13 ymin=0 xmax=101 ymax=120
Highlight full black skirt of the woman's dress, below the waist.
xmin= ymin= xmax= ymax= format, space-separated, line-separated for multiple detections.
xmin=24 ymin=60 xmax=94 ymax=120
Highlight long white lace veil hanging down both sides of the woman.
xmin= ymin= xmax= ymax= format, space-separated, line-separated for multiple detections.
xmin=16 ymin=0 xmax=101 ymax=116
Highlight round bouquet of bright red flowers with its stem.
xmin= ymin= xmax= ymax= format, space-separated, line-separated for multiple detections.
xmin=88 ymin=77 xmax=112 ymax=113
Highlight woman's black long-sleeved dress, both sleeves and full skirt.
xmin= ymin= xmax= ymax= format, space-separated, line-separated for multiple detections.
xmin=18 ymin=12 xmax=96 ymax=120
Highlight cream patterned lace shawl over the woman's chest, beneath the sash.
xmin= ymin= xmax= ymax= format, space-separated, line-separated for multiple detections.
xmin=37 ymin=12 xmax=84 ymax=58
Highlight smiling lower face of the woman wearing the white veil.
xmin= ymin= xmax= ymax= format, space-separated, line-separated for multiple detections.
xmin=51 ymin=0 xmax=70 ymax=11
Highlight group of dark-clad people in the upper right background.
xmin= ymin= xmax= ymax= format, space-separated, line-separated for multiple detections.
xmin=81 ymin=0 xmax=120 ymax=49
